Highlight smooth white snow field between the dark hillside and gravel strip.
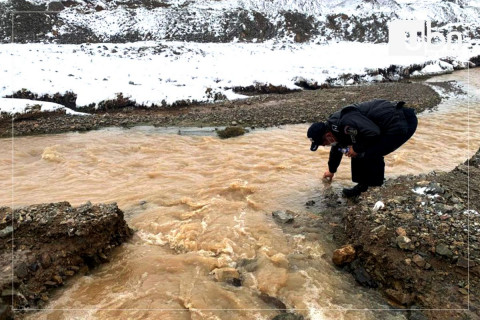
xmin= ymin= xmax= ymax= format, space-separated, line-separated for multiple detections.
xmin=0 ymin=41 xmax=480 ymax=112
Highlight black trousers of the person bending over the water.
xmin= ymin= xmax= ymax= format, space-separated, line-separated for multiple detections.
xmin=351 ymin=108 xmax=418 ymax=186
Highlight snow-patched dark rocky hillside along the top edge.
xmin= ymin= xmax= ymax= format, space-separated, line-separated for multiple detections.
xmin=0 ymin=0 xmax=480 ymax=43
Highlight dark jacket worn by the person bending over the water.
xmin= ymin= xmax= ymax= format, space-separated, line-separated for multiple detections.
xmin=327 ymin=100 xmax=408 ymax=173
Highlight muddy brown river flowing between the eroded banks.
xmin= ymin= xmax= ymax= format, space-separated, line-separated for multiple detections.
xmin=0 ymin=69 xmax=480 ymax=319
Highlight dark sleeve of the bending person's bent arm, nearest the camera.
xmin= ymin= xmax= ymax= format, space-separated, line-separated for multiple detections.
xmin=342 ymin=111 xmax=381 ymax=153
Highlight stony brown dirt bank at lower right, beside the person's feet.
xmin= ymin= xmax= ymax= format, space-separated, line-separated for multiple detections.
xmin=315 ymin=150 xmax=480 ymax=319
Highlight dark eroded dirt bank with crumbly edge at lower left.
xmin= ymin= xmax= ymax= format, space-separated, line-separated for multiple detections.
xmin=0 ymin=202 xmax=131 ymax=320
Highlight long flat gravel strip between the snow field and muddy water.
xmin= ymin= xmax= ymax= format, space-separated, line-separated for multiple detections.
xmin=0 ymin=82 xmax=442 ymax=137
